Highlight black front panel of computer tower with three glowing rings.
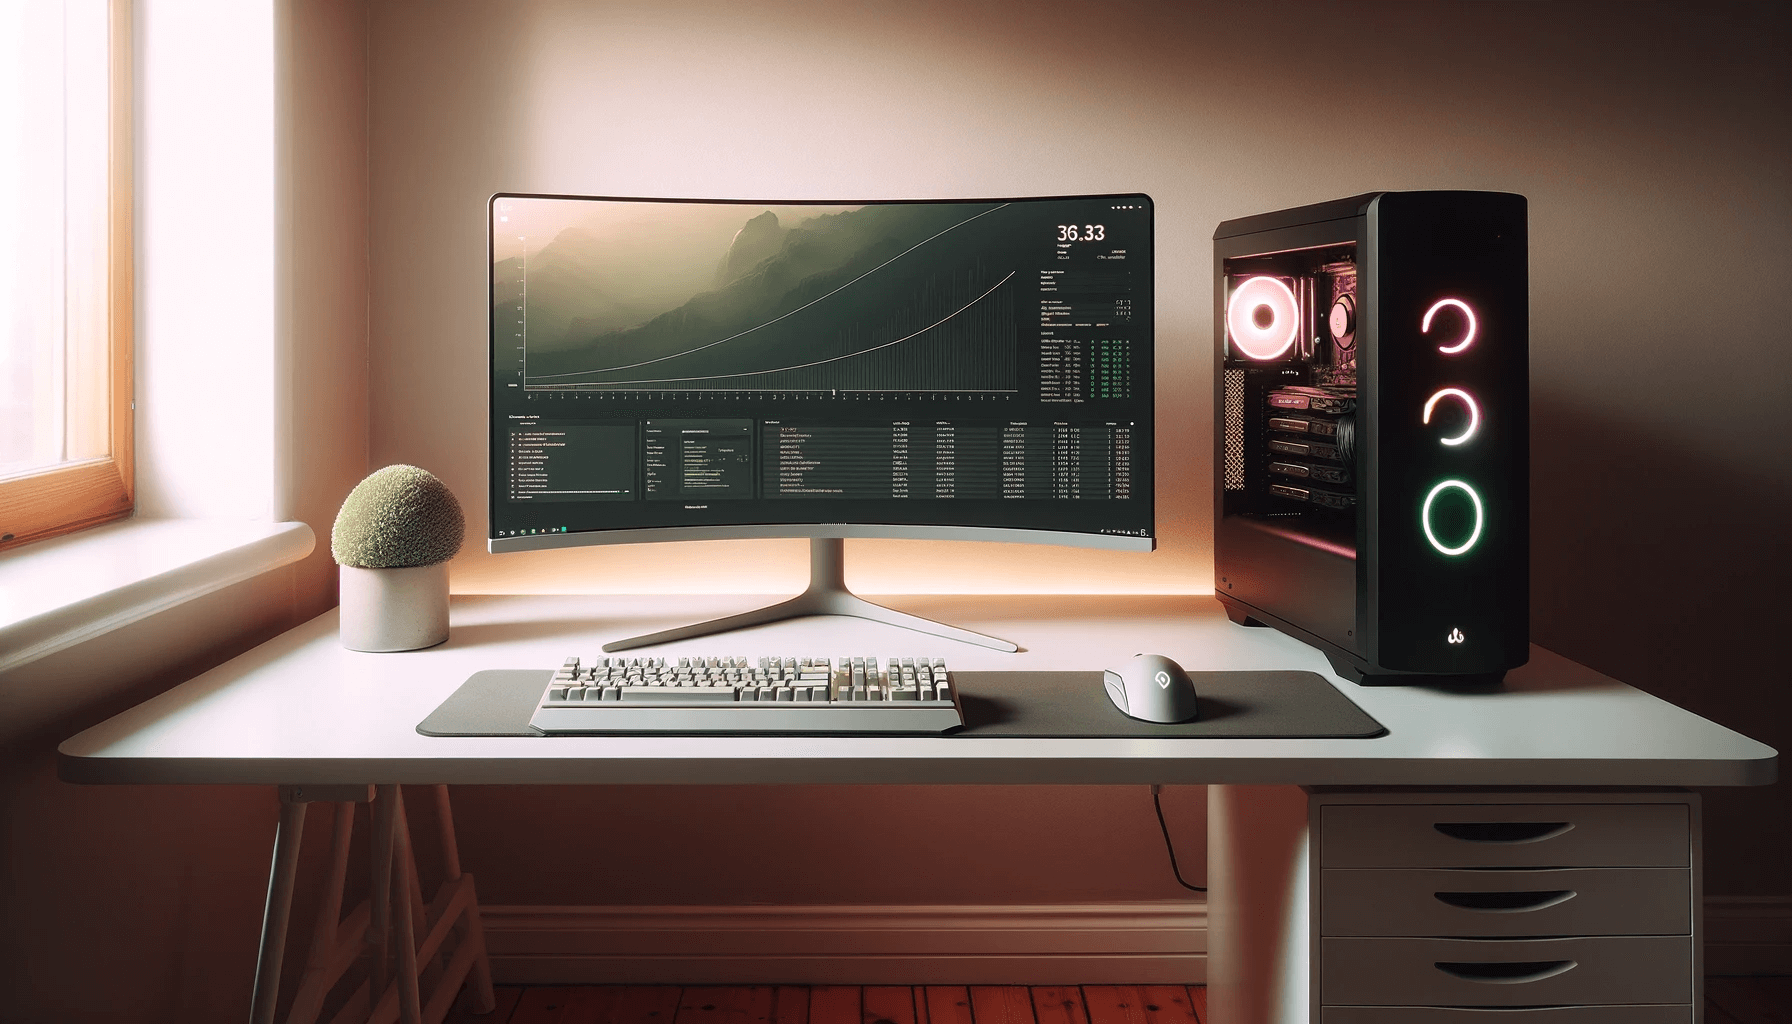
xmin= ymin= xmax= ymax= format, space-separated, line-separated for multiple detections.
xmin=1358 ymin=192 xmax=1530 ymax=674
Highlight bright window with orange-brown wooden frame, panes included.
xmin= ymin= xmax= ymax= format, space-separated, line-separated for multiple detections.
xmin=0 ymin=0 xmax=133 ymax=549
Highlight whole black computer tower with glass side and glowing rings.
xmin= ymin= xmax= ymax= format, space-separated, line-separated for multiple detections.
xmin=1213 ymin=192 xmax=1530 ymax=683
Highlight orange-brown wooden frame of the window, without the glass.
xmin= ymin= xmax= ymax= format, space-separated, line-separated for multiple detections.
xmin=0 ymin=0 xmax=136 ymax=551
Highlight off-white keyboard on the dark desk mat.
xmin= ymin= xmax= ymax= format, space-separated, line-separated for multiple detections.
xmin=529 ymin=656 xmax=964 ymax=733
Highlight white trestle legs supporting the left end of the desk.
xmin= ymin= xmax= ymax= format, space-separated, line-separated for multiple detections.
xmin=251 ymin=785 xmax=496 ymax=1024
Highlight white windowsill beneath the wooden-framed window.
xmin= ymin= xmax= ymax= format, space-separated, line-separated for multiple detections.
xmin=0 ymin=518 xmax=315 ymax=674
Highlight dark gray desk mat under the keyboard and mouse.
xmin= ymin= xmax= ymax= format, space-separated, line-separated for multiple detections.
xmin=418 ymin=669 xmax=1387 ymax=739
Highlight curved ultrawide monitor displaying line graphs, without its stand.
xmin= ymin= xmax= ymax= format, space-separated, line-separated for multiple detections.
xmin=487 ymin=194 xmax=1154 ymax=551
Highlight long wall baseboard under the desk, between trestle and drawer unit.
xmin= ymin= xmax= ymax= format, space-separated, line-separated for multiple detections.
xmin=480 ymin=902 xmax=1208 ymax=985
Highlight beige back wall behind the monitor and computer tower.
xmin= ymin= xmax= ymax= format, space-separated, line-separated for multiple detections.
xmin=371 ymin=2 xmax=1792 ymax=902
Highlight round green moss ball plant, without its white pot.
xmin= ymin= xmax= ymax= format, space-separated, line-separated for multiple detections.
xmin=330 ymin=466 xmax=466 ymax=568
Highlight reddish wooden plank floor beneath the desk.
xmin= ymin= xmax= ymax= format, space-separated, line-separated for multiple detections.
xmin=446 ymin=977 xmax=1792 ymax=1024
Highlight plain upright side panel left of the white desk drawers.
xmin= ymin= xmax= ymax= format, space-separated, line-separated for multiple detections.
xmin=1208 ymin=785 xmax=1312 ymax=1024
